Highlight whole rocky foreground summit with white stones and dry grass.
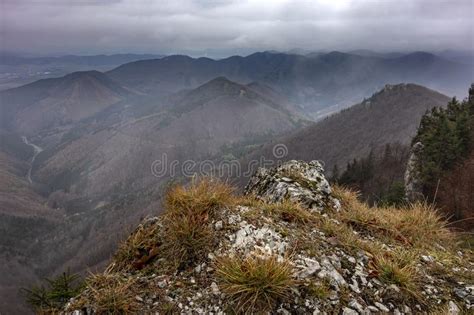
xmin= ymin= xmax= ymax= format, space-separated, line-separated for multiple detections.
xmin=62 ymin=161 xmax=474 ymax=315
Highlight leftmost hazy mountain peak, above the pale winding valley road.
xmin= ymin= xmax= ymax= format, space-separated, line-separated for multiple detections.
xmin=1 ymin=71 xmax=133 ymax=134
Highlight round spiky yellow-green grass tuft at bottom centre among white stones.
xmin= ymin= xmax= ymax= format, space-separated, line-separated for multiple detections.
xmin=216 ymin=256 xmax=296 ymax=314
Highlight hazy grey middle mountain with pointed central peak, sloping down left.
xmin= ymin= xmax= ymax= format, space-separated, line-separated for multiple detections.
xmin=33 ymin=77 xmax=307 ymax=200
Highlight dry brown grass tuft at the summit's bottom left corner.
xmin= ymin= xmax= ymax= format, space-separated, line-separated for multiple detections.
xmin=73 ymin=273 xmax=140 ymax=315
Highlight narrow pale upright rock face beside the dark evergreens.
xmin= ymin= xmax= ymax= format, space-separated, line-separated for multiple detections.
xmin=405 ymin=142 xmax=423 ymax=202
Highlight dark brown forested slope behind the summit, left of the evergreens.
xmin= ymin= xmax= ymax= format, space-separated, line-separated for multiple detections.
xmin=244 ymin=84 xmax=449 ymax=185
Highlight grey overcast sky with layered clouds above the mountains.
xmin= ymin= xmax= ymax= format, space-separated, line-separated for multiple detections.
xmin=0 ymin=0 xmax=474 ymax=54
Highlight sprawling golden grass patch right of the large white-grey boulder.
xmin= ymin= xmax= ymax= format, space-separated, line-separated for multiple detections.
xmin=330 ymin=187 xmax=462 ymax=303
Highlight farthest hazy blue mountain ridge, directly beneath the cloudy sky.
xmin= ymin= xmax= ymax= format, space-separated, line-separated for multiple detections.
xmin=107 ymin=51 xmax=474 ymax=118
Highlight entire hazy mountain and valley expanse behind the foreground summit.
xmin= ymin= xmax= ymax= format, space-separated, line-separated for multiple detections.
xmin=0 ymin=52 xmax=473 ymax=312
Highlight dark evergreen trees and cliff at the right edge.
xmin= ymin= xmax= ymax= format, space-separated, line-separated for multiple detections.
xmin=405 ymin=91 xmax=474 ymax=231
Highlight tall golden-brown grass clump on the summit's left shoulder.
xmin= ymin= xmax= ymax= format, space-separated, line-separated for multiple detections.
xmin=112 ymin=178 xmax=234 ymax=271
